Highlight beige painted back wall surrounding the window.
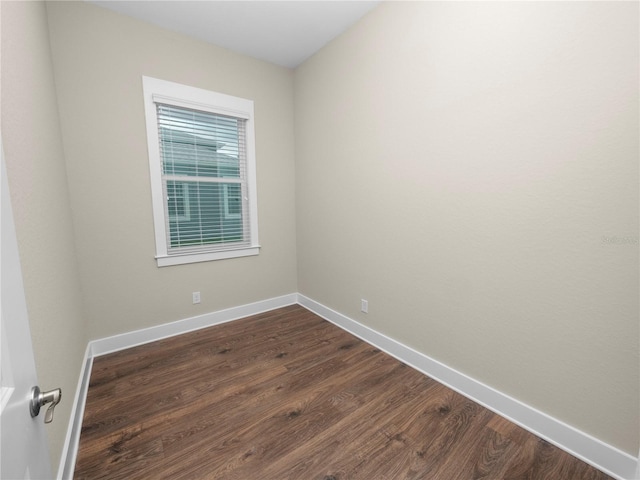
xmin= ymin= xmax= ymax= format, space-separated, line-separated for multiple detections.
xmin=47 ymin=2 xmax=296 ymax=339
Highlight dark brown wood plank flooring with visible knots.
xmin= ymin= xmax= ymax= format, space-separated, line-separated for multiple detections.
xmin=75 ymin=305 xmax=610 ymax=480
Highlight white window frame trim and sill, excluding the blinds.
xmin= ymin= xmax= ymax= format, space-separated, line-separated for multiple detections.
xmin=142 ymin=76 xmax=260 ymax=267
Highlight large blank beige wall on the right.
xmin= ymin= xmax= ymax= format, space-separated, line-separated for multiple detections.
xmin=294 ymin=2 xmax=639 ymax=455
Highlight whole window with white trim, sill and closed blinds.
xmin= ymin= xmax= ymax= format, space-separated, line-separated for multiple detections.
xmin=143 ymin=77 xmax=259 ymax=267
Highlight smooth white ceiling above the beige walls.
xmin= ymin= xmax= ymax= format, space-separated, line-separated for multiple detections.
xmin=89 ymin=0 xmax=380 ymax=68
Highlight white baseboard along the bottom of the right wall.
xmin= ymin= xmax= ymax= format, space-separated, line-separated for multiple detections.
xmin=298 ymin=294 xmax=638 ymax=480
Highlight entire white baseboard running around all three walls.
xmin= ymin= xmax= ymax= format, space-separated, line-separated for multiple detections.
xmin=58 ymin=293 xmax=640 ymax=480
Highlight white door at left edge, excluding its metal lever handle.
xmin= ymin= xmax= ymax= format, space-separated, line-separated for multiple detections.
xmin=0 ymin=142 xmax=53 ymax=480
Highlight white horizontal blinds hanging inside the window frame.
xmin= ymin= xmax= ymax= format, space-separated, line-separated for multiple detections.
xmin=156 ymin=103 xmax=250 ymax=254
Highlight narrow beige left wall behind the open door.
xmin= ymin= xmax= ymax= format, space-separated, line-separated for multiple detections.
xmin=0 ymin=2 xmax=86 ymax=471
